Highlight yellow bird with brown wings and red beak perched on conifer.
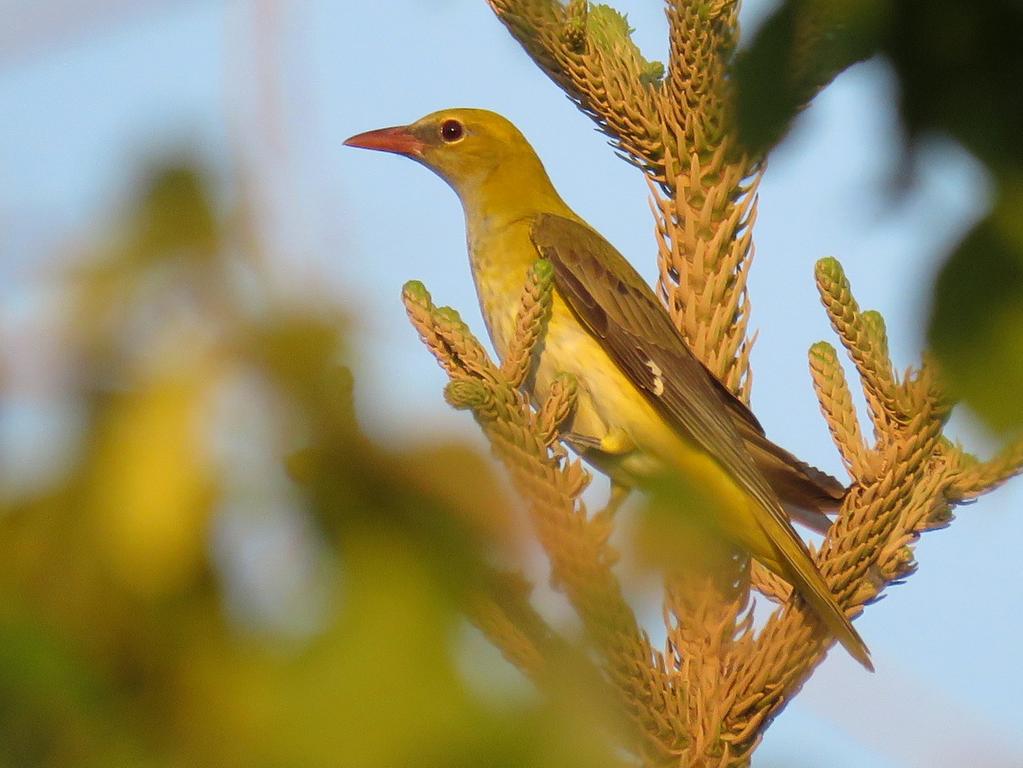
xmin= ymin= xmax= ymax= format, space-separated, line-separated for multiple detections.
xmin=344 ymin=108 xmax=874 ymax=671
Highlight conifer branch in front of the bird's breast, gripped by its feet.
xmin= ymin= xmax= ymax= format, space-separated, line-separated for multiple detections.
xmin=403 ymin=276 xmax=687 ymax=763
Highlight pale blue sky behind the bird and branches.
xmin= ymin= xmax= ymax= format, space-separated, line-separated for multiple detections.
xmin=0 ymin=0 xmax=1023 ymax=768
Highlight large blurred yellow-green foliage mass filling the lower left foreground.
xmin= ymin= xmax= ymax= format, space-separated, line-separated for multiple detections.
xmin=0 ymin=162 xmax=630 ymax=768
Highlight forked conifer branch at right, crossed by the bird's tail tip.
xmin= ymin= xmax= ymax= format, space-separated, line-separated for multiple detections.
xmin=723 ymin=260 xmax=957 ymax=754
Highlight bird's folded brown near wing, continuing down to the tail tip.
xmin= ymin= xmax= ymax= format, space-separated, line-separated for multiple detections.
xmin=532 ymin=214 xmax=873 ymax=669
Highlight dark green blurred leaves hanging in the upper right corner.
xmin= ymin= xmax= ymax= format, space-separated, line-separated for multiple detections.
xmin=738 ymin=0 xmax=1023 ymax=434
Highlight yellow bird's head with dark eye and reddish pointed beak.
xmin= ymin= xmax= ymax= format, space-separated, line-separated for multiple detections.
xmin=345 ymin=109 xmax=546 ymax=201
